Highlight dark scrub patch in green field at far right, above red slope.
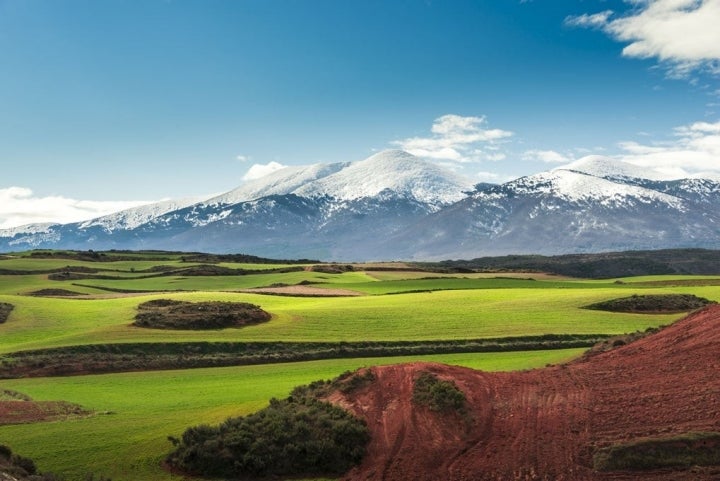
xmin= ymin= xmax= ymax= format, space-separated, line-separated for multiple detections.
xmin=585 ymin=294 xmax=714 ymax=314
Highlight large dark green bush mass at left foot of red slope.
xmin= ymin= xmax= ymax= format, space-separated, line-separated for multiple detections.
xmin=167 ymin=381 xmax=370 ymax=478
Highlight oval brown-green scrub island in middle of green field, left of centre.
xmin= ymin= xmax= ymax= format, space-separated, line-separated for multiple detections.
xmin=133 ymin=299 xmax=271 ymax=329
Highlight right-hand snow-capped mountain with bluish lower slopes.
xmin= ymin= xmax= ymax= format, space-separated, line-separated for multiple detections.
xmin=389 ymin=166 xmax=720 ymax=259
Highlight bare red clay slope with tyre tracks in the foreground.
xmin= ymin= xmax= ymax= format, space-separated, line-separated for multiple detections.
xmin=331 ymin=306 xmax=720 ymax=481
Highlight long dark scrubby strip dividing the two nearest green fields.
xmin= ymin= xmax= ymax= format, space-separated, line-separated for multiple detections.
xmin=0 ymin=334 xmax=610 ymax=379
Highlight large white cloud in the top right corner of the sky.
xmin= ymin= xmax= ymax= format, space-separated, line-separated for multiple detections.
xmin=565 ymin=0 xmax=720 ymax=77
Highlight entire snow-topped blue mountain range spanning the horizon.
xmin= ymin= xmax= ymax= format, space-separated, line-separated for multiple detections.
xmin=0 ymin=150 xmax=720 ymax=261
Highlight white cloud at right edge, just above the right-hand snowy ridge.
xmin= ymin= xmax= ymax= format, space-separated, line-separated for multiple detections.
xmin=618 ymin=121 xmax=720 ymax=178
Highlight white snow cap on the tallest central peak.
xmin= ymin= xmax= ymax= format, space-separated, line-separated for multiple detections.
xmin=294 ymin=150 xmax=472 ymax=206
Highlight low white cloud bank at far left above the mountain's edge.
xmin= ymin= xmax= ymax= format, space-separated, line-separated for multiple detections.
xmin=0 ymin=187 xmax=149 ymax=229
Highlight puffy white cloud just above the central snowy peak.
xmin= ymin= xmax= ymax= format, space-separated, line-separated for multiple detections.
xmin=391 ymin=114 xmax=513 ymax=163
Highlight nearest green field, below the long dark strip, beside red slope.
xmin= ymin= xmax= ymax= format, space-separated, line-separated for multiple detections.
xmin=0 ymin=349 xmax=583 ymax=481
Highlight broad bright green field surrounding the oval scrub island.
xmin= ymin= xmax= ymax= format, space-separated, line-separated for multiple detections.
xmin=0 ymin=285 xmax=708 ymax=353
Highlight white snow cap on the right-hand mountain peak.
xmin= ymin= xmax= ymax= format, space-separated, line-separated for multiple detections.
xmin=504 ymin=169 xmax=684 ymax=210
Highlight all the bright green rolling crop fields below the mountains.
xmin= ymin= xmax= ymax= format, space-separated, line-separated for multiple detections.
xmin=0 ymin=253 xmax=720 ymax=481
